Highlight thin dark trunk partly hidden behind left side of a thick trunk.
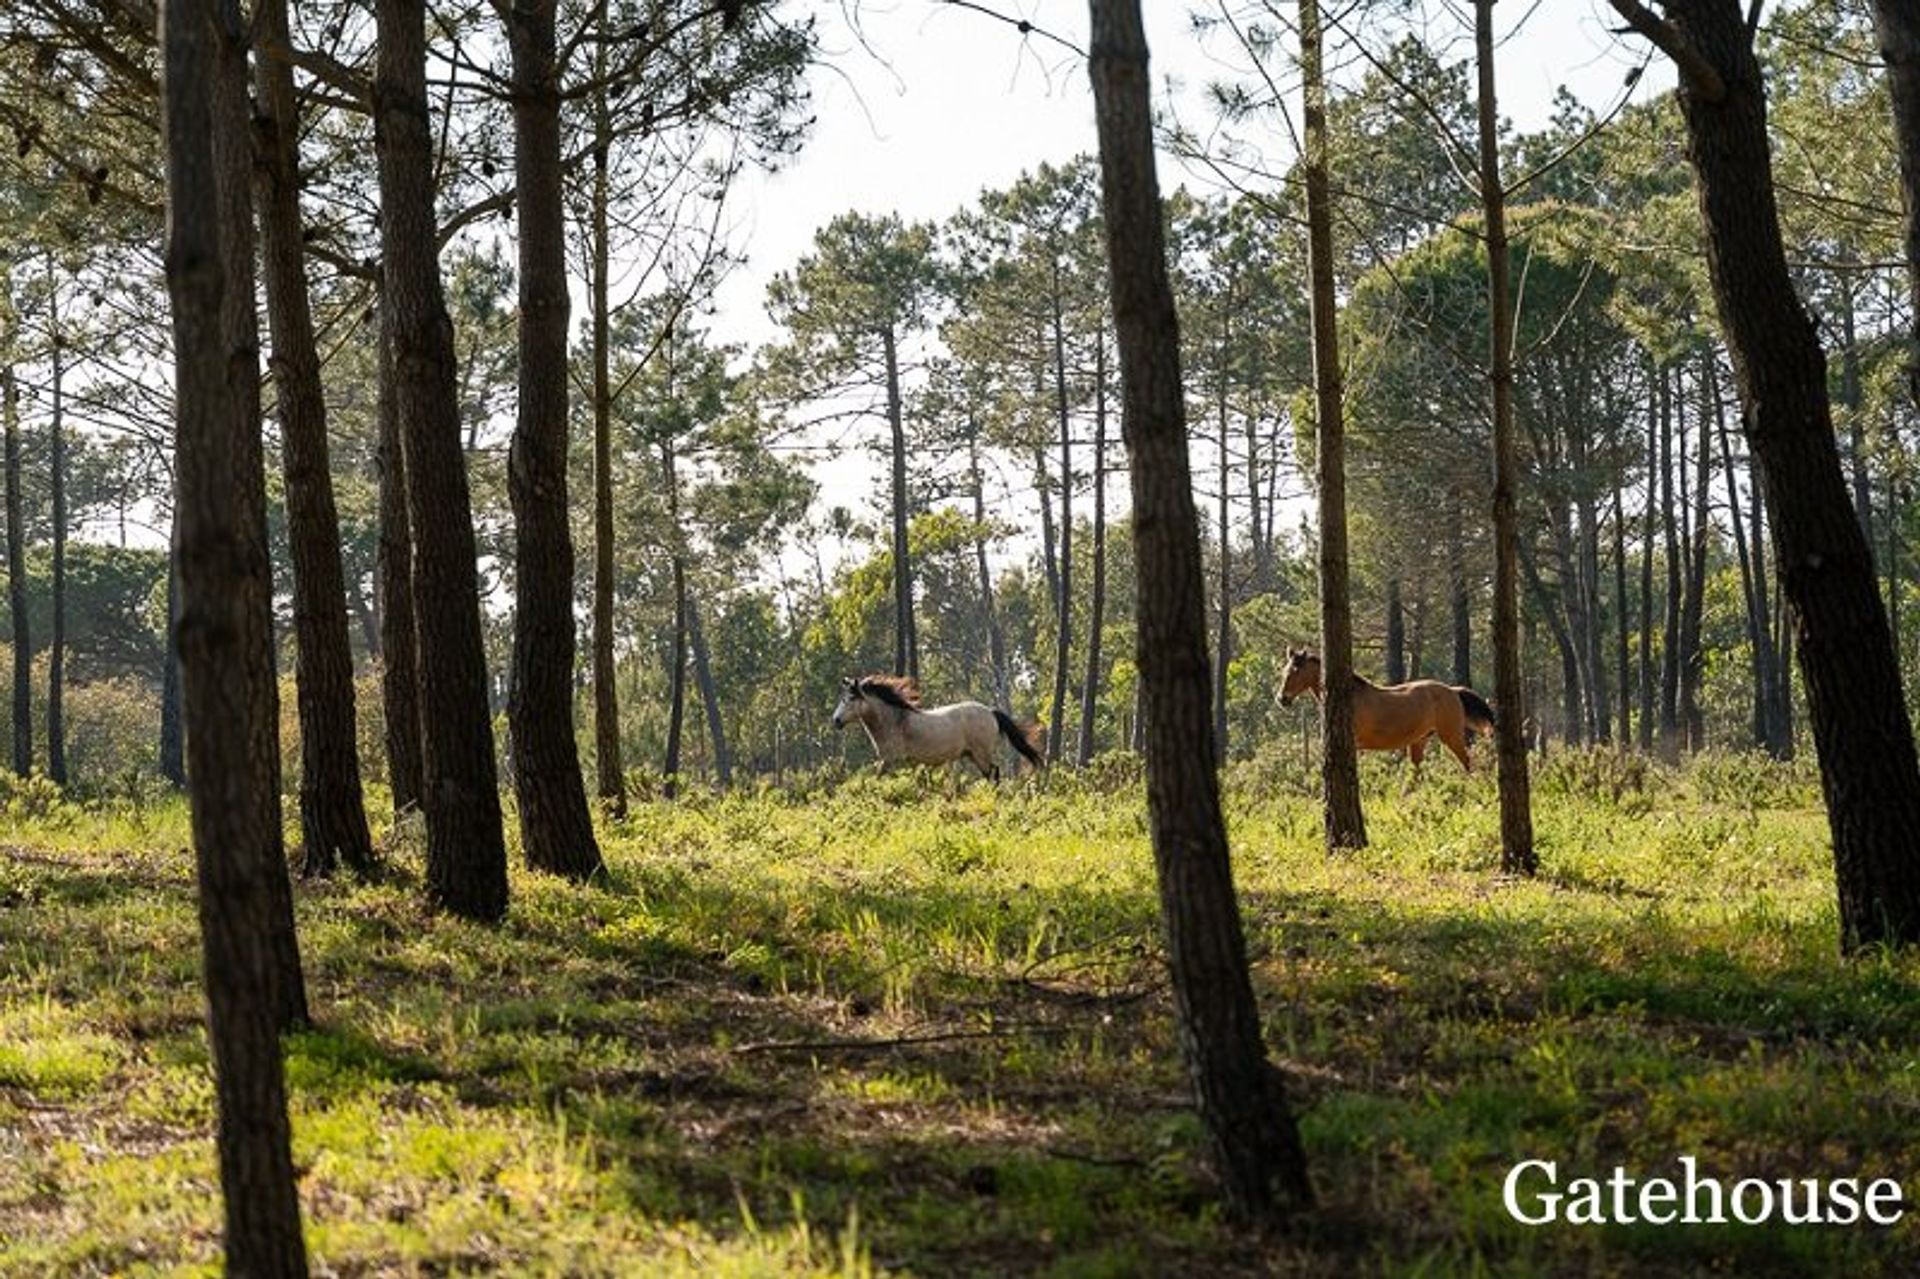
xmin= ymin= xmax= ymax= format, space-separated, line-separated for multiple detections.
xmin=374 ymin=300 xmax=424 ymax=816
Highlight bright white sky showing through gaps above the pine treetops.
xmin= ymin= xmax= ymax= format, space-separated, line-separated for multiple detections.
xmin=710 ymin=0 xmax=1672 ymax=583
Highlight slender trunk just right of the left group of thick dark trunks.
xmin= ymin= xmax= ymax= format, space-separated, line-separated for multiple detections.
xmin=588 ymin=12 xmax=626 ymax=820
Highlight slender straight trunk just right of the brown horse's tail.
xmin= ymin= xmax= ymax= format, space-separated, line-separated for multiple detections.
xmin=1473 ymin=0 xmax=1540 ymax=876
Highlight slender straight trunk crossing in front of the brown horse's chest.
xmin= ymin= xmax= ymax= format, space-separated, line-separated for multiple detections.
xmin=1300 ymin=0 xmax=1367 ymax=849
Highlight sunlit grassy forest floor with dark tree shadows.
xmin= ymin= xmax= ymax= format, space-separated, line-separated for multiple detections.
xmin=0 ymin=741 xmax=1920 ymax=1277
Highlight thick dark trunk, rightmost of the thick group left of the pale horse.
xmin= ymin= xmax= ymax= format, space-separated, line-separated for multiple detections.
xmin=507 ymin=0 xmax=607 ymax=880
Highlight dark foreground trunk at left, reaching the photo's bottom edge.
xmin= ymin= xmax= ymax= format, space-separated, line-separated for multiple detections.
xmin=159 ymin=0 xmax=307 ymax=1279
